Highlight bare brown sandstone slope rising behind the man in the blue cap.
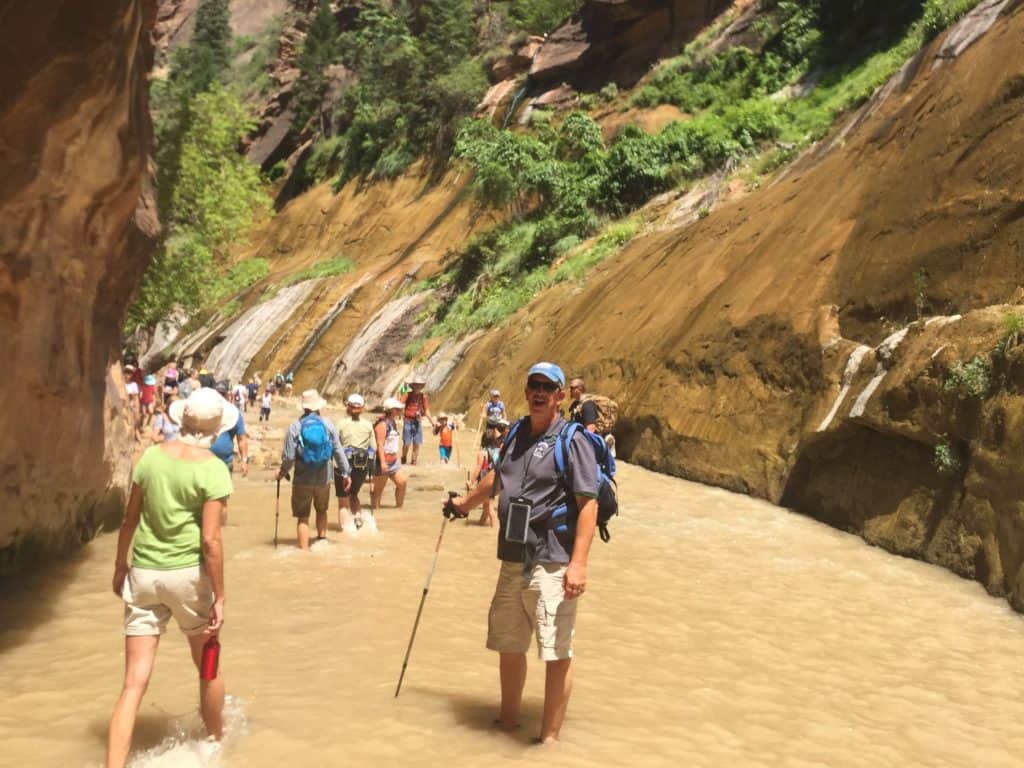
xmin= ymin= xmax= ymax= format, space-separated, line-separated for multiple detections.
xmin=446 ymin=0 xmax=1024 ymax=609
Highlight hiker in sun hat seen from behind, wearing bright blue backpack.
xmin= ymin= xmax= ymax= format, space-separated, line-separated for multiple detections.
xmin=274 ymin=389 xmax=351 ymax=549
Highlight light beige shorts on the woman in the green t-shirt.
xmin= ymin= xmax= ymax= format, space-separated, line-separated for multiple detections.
xmin=121 ymin=565 xmax=213 ymax=637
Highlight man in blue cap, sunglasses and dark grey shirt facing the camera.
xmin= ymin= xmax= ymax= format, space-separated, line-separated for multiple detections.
xmin=452 ymin=362 xmax=598 ymax=743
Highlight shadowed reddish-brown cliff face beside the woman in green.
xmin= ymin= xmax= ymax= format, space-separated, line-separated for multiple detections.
xmin=0 ymin=0 xmax=158 ymax=569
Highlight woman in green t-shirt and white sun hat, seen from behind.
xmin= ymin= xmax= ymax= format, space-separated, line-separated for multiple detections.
xmin=106 ymin=389 xmax=234 ymax=768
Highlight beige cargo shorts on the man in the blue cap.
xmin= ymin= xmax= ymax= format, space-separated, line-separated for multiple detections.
xmin=487 ymin=562 xmax=579 ymax=662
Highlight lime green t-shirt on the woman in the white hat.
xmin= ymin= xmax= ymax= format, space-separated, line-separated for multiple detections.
xmin=132 ymin=445 xmax=232 ymax=570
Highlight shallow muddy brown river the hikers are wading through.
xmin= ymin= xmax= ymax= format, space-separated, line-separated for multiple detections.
xmin=0 ymin=410 xmax=1024 ymax=768
